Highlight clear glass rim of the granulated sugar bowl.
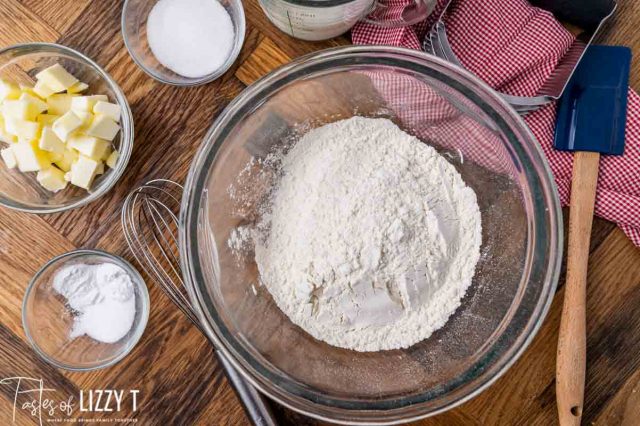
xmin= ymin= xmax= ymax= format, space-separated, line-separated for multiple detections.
xmin=120 ymin=0 xmax=246 ymax=87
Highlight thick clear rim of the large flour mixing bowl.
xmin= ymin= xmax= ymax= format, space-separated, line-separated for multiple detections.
xmin=180 ymin=46 xmax=563 ymax=424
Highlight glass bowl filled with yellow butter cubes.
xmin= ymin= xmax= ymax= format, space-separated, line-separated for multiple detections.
xmin=0 ymin=43 xmax=133 ymax=213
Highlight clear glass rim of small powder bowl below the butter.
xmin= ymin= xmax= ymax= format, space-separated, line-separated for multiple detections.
xmin=22 ymin=249 xmax=151 ymax=371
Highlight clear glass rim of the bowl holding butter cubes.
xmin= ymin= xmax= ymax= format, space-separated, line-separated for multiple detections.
xmin=0 ymin=43 xmax=134 ymax=214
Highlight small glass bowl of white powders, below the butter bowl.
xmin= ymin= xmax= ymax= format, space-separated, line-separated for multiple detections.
xmin=22 ymin=250 xmax=149 ymax=371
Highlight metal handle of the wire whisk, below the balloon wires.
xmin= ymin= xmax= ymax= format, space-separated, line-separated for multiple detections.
xmin=216 ymin=351 xmax=277 ymax=426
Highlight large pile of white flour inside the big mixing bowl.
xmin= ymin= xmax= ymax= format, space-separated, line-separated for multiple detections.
xmin=242 ymin=117 xmax=481 ymax=351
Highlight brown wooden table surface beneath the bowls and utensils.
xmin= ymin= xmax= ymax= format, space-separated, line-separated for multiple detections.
xmin=0 ymin=0 xmax=640 ymax=425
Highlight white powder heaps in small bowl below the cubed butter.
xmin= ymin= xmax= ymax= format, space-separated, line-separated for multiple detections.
xmin=53 ymin=263 xmax=136 ymax=343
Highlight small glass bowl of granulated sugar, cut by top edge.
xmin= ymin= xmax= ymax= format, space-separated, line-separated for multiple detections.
xmin=121 ymin=0 xmax=245 ymax=86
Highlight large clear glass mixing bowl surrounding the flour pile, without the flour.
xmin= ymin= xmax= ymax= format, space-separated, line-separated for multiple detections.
xmin=180 ymin=46 xmax=562 ymax=424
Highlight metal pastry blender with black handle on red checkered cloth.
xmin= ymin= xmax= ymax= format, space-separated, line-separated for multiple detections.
xmin=423 ymin=0 xmax=617 ymax=115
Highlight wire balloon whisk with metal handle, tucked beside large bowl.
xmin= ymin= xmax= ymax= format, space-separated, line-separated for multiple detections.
xmin=121 ymin=179 xmax=276 ymax=426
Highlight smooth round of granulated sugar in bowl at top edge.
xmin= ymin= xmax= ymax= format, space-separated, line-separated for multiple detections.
xmin=147 ymin=0 xmax=235 ymax=78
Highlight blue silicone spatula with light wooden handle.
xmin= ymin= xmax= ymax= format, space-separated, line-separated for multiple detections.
xmin=554 ymin=45 xmax=631 ymax=426
